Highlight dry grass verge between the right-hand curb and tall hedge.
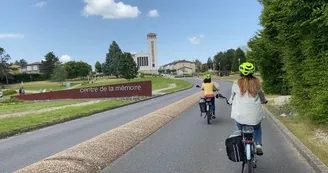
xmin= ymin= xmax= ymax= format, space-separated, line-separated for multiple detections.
xmin=265 ymin=105 xmax=328 ymax=166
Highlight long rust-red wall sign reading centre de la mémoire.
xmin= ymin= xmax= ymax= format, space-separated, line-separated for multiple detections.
xmin=13 ymin=81 xmax=152 ymax=100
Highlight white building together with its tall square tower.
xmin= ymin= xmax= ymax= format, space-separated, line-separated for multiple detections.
xmin=132 ymin=33 xmax=158 ymax=74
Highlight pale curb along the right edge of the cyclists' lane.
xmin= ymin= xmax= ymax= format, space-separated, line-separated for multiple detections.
xmin=263 ymin=107 xmax=328 ymax=173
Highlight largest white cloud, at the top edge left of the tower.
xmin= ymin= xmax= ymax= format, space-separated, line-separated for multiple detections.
xmin=83 ymin=0 xmax=140 ymax=19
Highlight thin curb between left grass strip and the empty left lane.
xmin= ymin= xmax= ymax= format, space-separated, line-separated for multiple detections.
xmin=0 ymin=84 xmax=194 ymax=140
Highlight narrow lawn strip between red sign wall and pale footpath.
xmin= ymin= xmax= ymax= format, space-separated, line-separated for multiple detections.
xmin=0 ymin=100 xmax=86 ymax=115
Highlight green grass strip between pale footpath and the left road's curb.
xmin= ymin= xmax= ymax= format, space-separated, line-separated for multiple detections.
xmin=0 ymin=100 xmax=134 ymax=138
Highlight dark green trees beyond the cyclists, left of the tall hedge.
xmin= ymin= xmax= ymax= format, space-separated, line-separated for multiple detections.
xmin=195 ymin=48 xmax=246 ymax=76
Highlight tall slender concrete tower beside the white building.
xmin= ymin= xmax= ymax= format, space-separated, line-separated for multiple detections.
xmin=147 ymin=33 xmax=158 ymax=73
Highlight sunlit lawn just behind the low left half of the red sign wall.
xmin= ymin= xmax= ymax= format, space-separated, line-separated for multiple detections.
xmin=5 ymin=81 xmax=80 ymax=91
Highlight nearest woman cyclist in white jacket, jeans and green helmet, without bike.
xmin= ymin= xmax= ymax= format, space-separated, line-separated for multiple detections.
xmin=229 ymin=62 xmax=267 ymax=155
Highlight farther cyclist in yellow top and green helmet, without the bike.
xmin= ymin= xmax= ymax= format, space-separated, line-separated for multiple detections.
xmin=201 ymin=73 xmax=219 ymax=119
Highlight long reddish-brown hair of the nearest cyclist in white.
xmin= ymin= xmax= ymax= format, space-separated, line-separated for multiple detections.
xmin=238 ymin=75 xmax=261 ymax=97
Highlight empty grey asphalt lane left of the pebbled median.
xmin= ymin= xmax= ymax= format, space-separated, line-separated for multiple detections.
xmin=0 ymin=79 xmax=201 ymax=173
